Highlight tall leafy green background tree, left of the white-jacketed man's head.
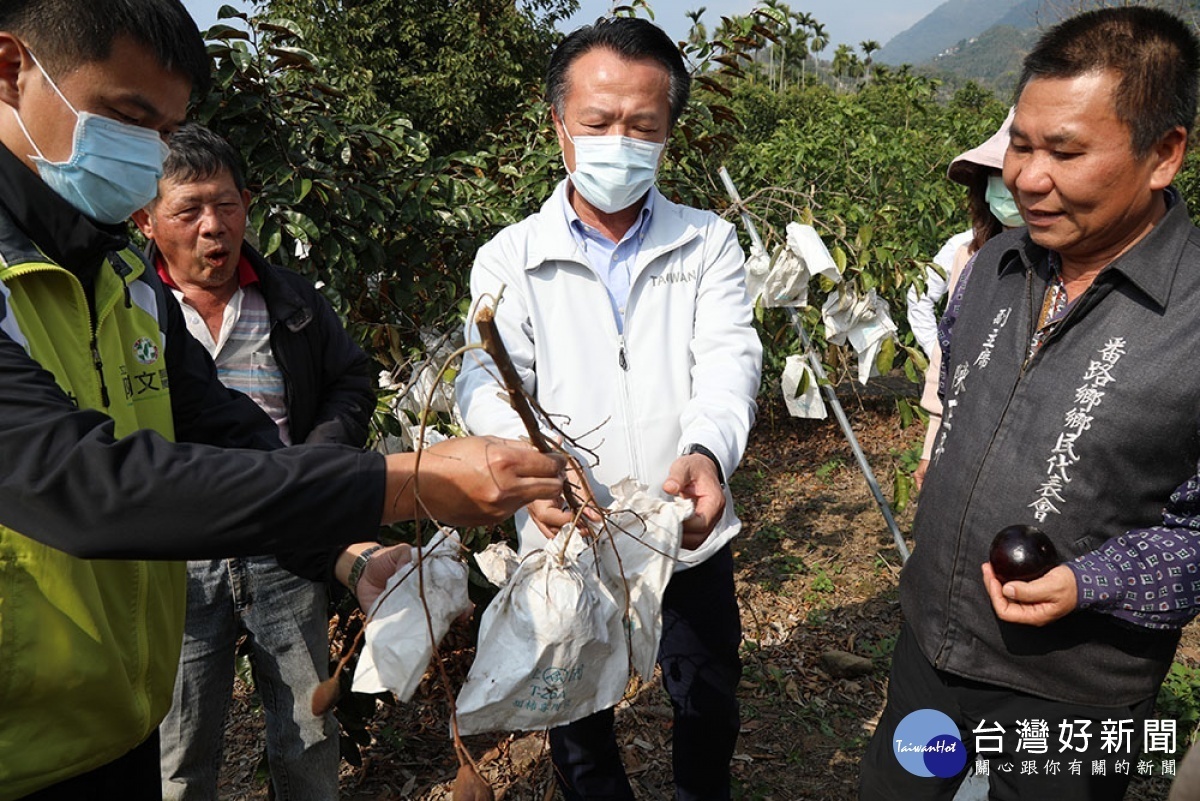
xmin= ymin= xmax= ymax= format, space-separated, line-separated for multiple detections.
xmin=262 ymin=0 xmax=578 ymax=155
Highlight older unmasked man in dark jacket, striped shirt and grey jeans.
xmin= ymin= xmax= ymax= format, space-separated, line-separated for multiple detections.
xmin=134 ymin=125 xmax=374 ymax=801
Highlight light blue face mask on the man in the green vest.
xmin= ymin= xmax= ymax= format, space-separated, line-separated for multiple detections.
xmin=10 ymin=54 xmax=168 ymax=224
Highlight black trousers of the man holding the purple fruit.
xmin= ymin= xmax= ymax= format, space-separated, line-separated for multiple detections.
xmin=858 ymin=625 xmax=1154 ymax=801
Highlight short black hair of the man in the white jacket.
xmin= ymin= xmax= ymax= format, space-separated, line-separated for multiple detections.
xmin=546 ymin=17 xmax=691 ymax=127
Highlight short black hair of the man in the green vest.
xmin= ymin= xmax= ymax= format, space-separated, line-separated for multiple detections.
xmin=0 ymin=0 xmax=212 ymax=95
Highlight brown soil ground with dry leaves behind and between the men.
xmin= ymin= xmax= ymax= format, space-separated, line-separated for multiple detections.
xmin=221 ymin=383 xmax=1200 ymax=801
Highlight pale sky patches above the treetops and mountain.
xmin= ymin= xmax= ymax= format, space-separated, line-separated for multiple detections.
xmin=184 ymin=0 xmax=943 ymax=58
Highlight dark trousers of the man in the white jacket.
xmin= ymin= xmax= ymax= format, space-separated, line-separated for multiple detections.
xmin=550 ymin=546 xmax=742 ymax=801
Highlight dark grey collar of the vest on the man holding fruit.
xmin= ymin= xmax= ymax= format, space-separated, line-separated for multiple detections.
xmin=997 ymin=187 xmax=1194 ymax=308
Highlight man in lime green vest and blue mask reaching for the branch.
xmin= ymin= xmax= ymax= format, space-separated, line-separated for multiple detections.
xmin=0 ymin=0 xmax=563 ymax=801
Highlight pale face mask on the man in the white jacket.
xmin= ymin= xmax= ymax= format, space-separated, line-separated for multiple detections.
xmin=563 ymin=124 xmax=665 ymax=215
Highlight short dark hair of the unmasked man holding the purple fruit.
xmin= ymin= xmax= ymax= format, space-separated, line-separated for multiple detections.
xmin=1016 ymin=6 xmax=1200 ymax=158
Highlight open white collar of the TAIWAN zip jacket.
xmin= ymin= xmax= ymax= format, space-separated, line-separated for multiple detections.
xmin=524 ymin=179 xmax=701 ymax=283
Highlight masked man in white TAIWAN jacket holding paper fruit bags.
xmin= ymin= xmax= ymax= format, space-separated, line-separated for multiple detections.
xmin=457 ymin=18 xmax=762 ymax=800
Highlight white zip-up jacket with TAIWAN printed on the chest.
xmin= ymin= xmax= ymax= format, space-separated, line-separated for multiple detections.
xmin=456 ymin=180 xmax=762 ymax=570
